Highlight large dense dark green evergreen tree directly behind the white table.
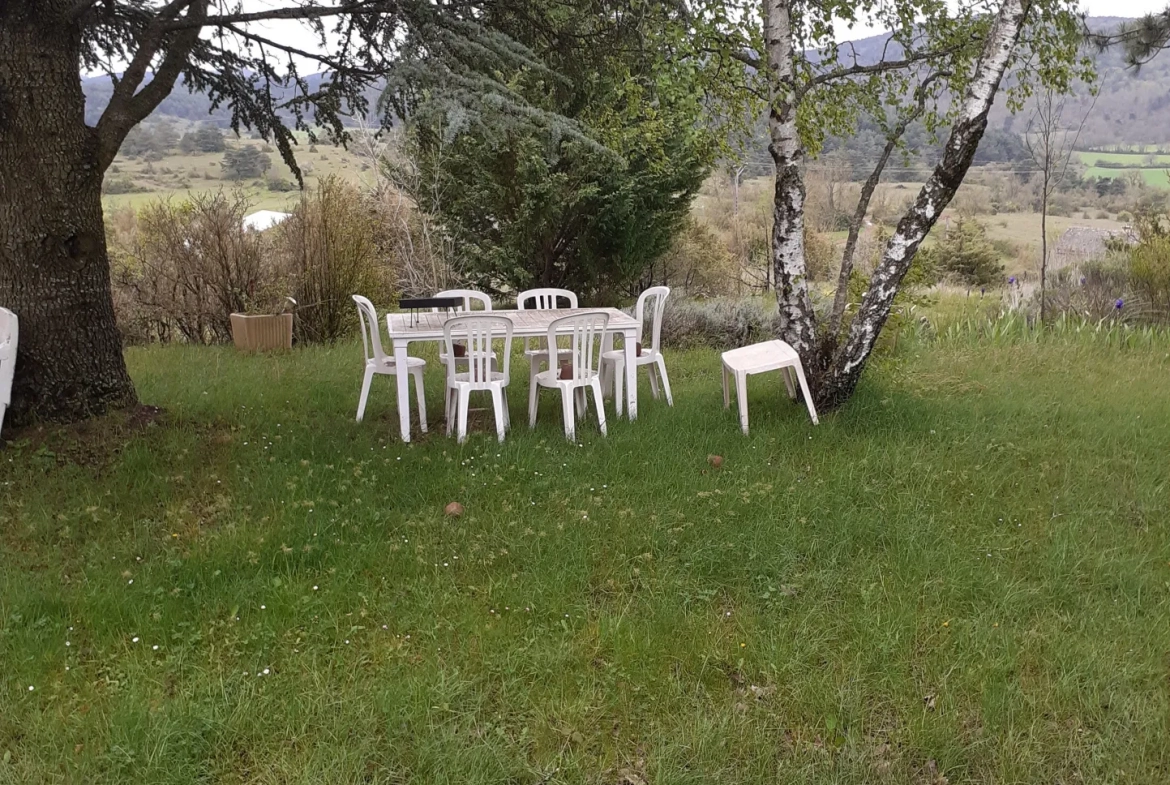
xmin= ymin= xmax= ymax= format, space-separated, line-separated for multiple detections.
xmin=395 ymin=4 xmax=715 ymax=298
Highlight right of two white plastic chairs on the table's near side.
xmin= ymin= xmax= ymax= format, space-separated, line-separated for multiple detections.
xmin=528 ymin=311 xmax=610 ymax=441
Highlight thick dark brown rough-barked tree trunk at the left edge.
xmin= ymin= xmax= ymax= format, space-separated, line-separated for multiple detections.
xmin=0 ymin=0 xmax=136 ymax=424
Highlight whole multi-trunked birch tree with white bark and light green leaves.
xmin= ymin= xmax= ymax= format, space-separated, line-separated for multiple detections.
xmin=692 ymin=0 xmax=1088 ymax=408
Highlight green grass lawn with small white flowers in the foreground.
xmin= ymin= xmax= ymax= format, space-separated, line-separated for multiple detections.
xmin=0 ymin=338 xmax=1170 ymax=785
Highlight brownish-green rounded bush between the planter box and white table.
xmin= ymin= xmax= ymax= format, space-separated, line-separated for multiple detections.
xmin=275 ymin=177 xmax=393 ymax=342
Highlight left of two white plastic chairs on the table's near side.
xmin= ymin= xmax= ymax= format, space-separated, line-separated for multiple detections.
xmin=442 ymin=316 xmax=512 ymax=443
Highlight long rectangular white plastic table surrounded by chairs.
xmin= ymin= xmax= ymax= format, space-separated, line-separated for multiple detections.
xmin=386 ymin=308 xmax=638 ymax=441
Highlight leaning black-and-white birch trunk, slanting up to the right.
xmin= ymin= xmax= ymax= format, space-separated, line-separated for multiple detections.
xmin=815 ymin=0 xmax=1031 ymax=408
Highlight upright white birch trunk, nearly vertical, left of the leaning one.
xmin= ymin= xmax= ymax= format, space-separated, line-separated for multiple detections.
xmin=764 ymin=0 xmax=819 ymax=360
